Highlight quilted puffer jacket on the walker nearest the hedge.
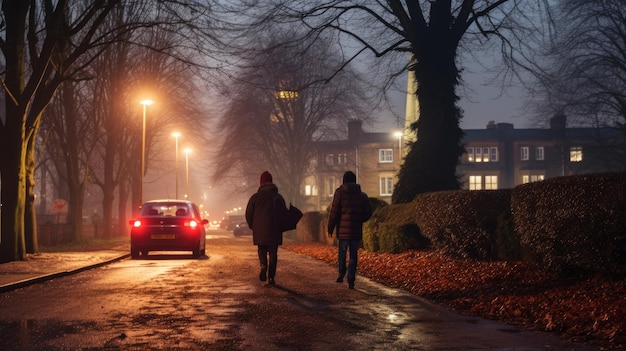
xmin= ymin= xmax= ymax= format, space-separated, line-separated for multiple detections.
xmin=328 ymin=183 xmax=372 ymax=240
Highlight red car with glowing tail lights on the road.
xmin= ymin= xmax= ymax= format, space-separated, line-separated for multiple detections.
xmin=129 ymin=199 xmax=209 ymax=258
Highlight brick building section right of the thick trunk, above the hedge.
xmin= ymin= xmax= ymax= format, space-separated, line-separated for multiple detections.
xmin=457 ymin=116 xmax=624 ymax=190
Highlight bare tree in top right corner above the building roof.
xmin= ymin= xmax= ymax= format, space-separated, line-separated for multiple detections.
xmin=537 ymin=0 xmax=626 ymax=127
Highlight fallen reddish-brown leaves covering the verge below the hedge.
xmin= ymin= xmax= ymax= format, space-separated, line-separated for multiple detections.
xmin=283 ymin=243 xmax=626 ymax=350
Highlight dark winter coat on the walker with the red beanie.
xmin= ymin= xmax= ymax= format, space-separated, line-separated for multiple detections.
xmin=246 ymin=183 xmax=288 ymax=245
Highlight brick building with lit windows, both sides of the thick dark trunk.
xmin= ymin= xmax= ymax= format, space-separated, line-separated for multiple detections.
xmin=302 ymin=116 xmax=626 ymax=211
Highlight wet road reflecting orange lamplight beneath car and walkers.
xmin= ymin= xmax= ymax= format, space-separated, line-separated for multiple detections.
xmin=0 ymin=231 xmax=597 ymax=351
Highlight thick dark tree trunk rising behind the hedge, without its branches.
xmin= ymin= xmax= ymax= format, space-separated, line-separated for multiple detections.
xmin=392 ymin=39 xmax=463 ymax=203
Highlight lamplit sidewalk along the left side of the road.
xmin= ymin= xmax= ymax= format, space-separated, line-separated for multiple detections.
xmin=0 ymin=245 xmax=130 ymax=293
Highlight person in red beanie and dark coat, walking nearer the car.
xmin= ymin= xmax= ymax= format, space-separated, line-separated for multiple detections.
xmin=246 ymin=171 xmax=288 ymax=285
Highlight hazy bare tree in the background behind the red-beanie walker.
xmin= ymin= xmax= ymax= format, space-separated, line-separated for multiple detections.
xmin=214 ymin=34 xmax=370 ymax=208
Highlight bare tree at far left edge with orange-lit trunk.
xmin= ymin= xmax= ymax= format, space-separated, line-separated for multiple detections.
xmin=0 ymin=0 xmax=219 ymax=262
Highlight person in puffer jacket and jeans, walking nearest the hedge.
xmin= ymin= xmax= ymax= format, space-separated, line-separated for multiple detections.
xmin=328 ymin=171 xmax=372 ymax=289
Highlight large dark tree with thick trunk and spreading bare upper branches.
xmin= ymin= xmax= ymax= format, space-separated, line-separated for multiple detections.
xmin=223 ymin=0 xmax=543 ymax=202
